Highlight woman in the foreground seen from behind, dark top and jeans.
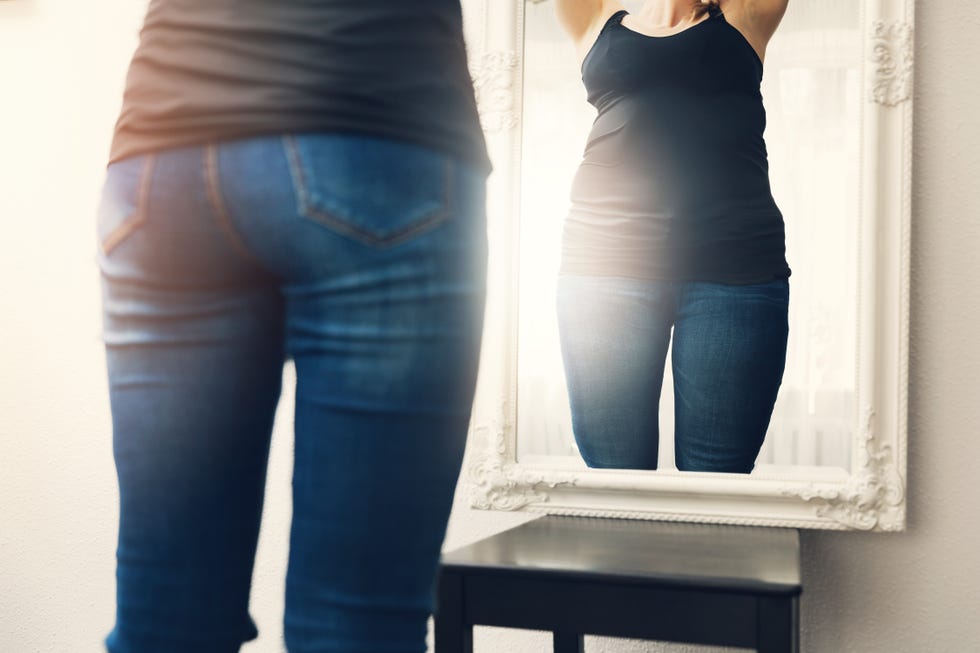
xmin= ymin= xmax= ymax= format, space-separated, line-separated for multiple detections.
xmin=98 ymin=0 xmax=489 ymax=653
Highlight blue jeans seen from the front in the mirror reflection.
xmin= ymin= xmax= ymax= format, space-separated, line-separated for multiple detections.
xmin=557 ymin=275 xmax=789 ymax=473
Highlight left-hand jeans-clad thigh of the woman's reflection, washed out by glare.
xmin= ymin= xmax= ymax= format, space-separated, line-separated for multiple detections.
xmin=557 ymin=275 xmax=676 ymax=469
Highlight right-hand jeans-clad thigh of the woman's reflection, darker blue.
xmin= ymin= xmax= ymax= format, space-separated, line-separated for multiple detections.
xmin=671 ymin=279 xmax=789 ymax=473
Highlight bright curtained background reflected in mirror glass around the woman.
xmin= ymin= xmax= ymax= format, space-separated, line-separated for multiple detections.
xmin=517 ymin=0 xmax=862 ymax=475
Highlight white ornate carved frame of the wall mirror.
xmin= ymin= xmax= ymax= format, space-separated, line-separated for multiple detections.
xmin=461 ymin=0 xmax=914 ymax=531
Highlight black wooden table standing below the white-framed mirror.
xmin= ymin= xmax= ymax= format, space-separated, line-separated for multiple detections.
xmin=435 ymin=517 xmax=801 ymax=653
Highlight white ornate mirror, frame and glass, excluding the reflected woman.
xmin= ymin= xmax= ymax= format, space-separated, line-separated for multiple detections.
xmin=464 ymin=0 xmax=912 ymax=530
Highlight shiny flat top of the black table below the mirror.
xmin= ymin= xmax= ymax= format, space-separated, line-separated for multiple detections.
xmin=442 ymin=516 xmax=801 ymax=594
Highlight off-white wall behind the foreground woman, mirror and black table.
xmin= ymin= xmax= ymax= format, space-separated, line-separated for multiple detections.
xmin=0 ymin=0 xmax=980 ymax=653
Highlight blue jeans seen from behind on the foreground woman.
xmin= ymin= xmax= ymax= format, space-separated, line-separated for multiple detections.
xmin=98 ymin=134 xmax=486 ymax=653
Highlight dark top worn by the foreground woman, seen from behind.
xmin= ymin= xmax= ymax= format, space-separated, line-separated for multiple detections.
xmin=110 ymin=0 xmax=489 ymax=169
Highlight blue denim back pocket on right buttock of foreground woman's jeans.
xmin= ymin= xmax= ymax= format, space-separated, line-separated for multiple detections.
xmin=284 ymin=134 xmax=453 ymax=248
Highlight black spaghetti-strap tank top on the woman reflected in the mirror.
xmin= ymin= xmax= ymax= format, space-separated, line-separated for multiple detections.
xmin=561 ymin=8 xmax=790 ymax=284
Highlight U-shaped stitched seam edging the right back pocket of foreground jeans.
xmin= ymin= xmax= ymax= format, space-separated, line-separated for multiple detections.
xmin=282 ymin=135 xmax=455 ymax=249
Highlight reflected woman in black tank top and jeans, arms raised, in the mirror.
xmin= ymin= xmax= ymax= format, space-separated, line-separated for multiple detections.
xmin=557 ymin=0 xmax=790 ymax=473
